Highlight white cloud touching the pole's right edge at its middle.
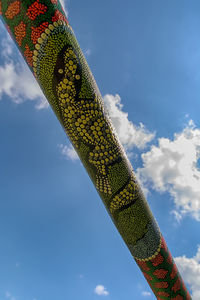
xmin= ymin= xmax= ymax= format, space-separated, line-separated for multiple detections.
xmin=104 ymin=94 xmax=155 ymax=150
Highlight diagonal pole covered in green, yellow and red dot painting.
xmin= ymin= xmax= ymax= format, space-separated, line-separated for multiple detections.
xmin=0 ymin=0 xmax=191 ymax=300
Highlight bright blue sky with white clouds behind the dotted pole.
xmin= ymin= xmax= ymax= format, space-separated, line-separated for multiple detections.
xmin=0 ymin=0 xmax=200 ymax=300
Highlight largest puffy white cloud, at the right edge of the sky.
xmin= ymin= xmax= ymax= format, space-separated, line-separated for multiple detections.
xmin=137 ymin=121 xmax=200 ymax=221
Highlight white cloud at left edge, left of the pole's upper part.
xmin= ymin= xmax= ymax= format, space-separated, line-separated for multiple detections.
xmin=0 ymin=26 xmax=49 ymax=109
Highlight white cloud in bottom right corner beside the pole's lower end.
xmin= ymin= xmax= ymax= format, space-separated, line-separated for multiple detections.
xmin=174 ymin=246 xmax=200 ymax=300
